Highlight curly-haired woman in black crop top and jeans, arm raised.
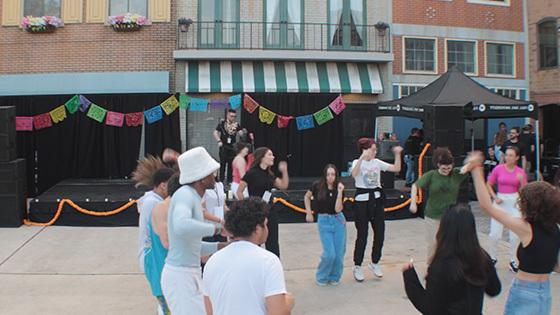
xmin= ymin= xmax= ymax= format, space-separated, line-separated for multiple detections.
xmin=465 ymin=152 xmax=560 ymax=315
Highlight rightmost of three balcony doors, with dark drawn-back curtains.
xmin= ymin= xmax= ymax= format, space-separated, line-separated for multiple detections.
xmin=328 ymin=0 xmax=366 ymax=50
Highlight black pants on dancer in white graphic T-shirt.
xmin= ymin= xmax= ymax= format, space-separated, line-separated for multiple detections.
xmin=354 ymin=190 xmax=385 ymax=266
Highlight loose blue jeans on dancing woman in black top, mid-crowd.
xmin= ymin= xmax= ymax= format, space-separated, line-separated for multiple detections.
xmin=315 ymin=212 xmax=346 ymax=283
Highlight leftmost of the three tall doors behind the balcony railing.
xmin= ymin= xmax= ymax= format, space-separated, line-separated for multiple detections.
xmin=198 ymin=0 xmax=239 ymax=48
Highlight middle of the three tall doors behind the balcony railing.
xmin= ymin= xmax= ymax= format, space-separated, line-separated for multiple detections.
xmin=264 ymin=0 xmax=303 ymax=49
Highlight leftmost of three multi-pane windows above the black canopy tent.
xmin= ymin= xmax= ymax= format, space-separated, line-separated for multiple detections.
xmin=404 ymin=38 xmax=436 ymax=72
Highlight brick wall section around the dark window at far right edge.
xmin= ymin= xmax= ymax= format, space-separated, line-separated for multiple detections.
xmin=528 ymin=0 xmax=560 ymax=104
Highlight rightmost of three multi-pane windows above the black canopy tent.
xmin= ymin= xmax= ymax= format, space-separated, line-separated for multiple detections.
xmin=486 ymin=43 xmax=515 ymax=76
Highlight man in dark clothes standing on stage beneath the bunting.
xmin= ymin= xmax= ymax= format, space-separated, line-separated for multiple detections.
xmin=213 ymin=109 xmax=241 ymax=186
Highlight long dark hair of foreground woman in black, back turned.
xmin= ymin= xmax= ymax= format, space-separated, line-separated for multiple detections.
xmin=432 ymin=204 xmax=491 ymax=286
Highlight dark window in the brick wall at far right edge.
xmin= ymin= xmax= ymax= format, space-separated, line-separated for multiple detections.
xmin=537 ymin=20 xmax=558 ymax=68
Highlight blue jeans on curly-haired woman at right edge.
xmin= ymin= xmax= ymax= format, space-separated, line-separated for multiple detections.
xmin=504 ymin=279 xmax=552 ymax=315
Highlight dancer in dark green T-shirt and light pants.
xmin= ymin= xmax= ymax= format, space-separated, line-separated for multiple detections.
xmin=410 ymin=148 xmax=468 ymax=261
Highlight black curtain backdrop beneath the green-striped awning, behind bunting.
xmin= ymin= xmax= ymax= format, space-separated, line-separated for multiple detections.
xmin=241 ymin=93 xmax=344 ymax=177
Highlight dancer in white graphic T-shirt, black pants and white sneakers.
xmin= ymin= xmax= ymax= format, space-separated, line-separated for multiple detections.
xmin=351 ymin=138 xmax=403 ymax=282
